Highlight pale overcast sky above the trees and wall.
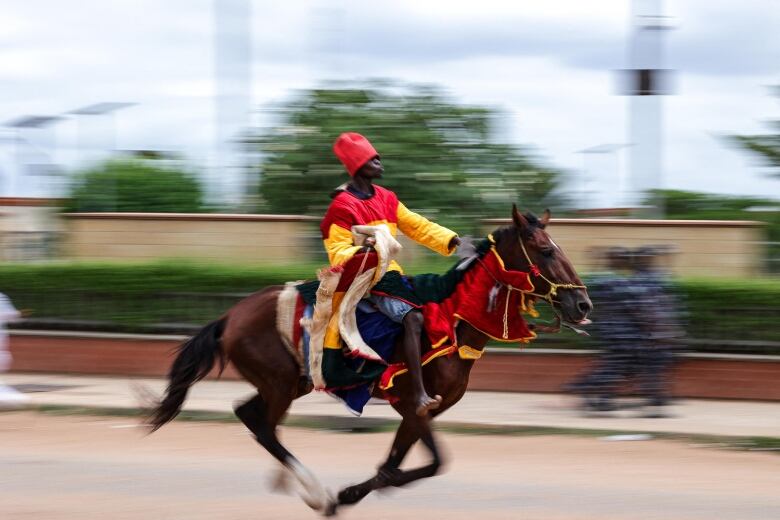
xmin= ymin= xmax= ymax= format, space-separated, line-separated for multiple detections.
xmin=0 ymin=0 xmax=780 ymax=203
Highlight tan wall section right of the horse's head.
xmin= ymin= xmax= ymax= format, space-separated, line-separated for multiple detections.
xmin=484 ymin=219 xmax=766 ymax=278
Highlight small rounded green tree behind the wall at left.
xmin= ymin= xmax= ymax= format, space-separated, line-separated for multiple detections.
xmin=65 ymin=159 xmax=206 ymax=213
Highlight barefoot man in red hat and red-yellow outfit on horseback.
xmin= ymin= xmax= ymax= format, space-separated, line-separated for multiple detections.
xmin=320 ymin=132 xmax=460 ymax=415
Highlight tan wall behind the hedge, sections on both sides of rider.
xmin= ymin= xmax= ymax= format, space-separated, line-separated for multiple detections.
xmin=61 ymin=213 xmax=765 ymax=277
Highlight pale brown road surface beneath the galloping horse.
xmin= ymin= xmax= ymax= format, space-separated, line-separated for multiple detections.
xmin=0 ymin=412 xmax=780 ymax=520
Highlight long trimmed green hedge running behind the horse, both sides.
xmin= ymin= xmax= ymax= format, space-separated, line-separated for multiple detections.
xmin=0 ymin=261 xmax=780 ymax=353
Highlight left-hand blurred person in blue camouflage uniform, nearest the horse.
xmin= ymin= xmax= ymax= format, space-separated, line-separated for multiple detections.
xmin=565 ymin=247 xmax=652 ymax=411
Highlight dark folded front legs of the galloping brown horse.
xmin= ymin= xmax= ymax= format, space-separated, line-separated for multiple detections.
xmin=333 ymin=413 xmax=442 ymax=512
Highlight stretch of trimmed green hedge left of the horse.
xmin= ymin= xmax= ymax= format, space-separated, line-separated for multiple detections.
xmin=0 ymin=261 xmax=316 ymax=332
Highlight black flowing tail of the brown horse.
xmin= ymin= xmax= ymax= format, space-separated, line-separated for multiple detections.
xmin=147 ymin=317 xmax=227 ymax=432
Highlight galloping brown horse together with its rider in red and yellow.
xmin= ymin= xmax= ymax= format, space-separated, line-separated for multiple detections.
xmin=147 ymin=134 xmax=592 ymax=515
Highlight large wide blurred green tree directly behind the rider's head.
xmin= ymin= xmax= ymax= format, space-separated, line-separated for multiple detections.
xmin=247 ymin=81 xmax=560 ymax=232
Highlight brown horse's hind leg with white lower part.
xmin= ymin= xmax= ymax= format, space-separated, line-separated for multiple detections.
xmin=235 ymin=394 xmax=331 ymax=510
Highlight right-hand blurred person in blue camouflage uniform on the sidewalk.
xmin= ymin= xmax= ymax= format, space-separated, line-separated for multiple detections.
xmin=631 ymin=246 xmax=684 ymax=417
